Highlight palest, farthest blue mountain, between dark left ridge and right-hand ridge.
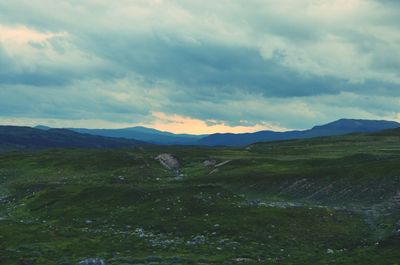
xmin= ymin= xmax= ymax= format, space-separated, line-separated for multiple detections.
xmin=35 ymin=125 xmax=206 ymax=145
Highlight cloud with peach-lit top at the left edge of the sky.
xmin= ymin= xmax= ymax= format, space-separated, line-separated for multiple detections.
xmin=0 ymin=24 xmax=119 ymax=86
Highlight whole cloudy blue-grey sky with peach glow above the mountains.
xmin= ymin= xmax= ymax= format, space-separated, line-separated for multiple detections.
xmin=0 ymin=0 xmax=400 ymax=134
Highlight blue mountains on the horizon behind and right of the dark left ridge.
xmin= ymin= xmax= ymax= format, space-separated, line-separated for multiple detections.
xmin=36 ymin=119 xmax=400 ymax=146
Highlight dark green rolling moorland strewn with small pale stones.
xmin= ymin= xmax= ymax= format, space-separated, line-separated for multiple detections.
xmin=0 ymin=133 xmax=400 ymax=265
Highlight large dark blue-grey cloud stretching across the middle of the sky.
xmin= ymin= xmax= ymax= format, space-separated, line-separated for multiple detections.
xmin=85 ymin=33 xmax=376 ymax=99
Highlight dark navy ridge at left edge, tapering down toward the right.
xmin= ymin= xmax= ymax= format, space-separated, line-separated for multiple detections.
xmin=0 ymin=126 xmax=146 ymax=151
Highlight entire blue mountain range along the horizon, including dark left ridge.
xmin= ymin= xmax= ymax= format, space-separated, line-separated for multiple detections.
xmin=0 ymin=119 xmax=400 ymax=151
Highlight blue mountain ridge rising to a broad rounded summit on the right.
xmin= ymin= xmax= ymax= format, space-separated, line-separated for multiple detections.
xmin=197 ymin=119 xmax=400 ymax=146
